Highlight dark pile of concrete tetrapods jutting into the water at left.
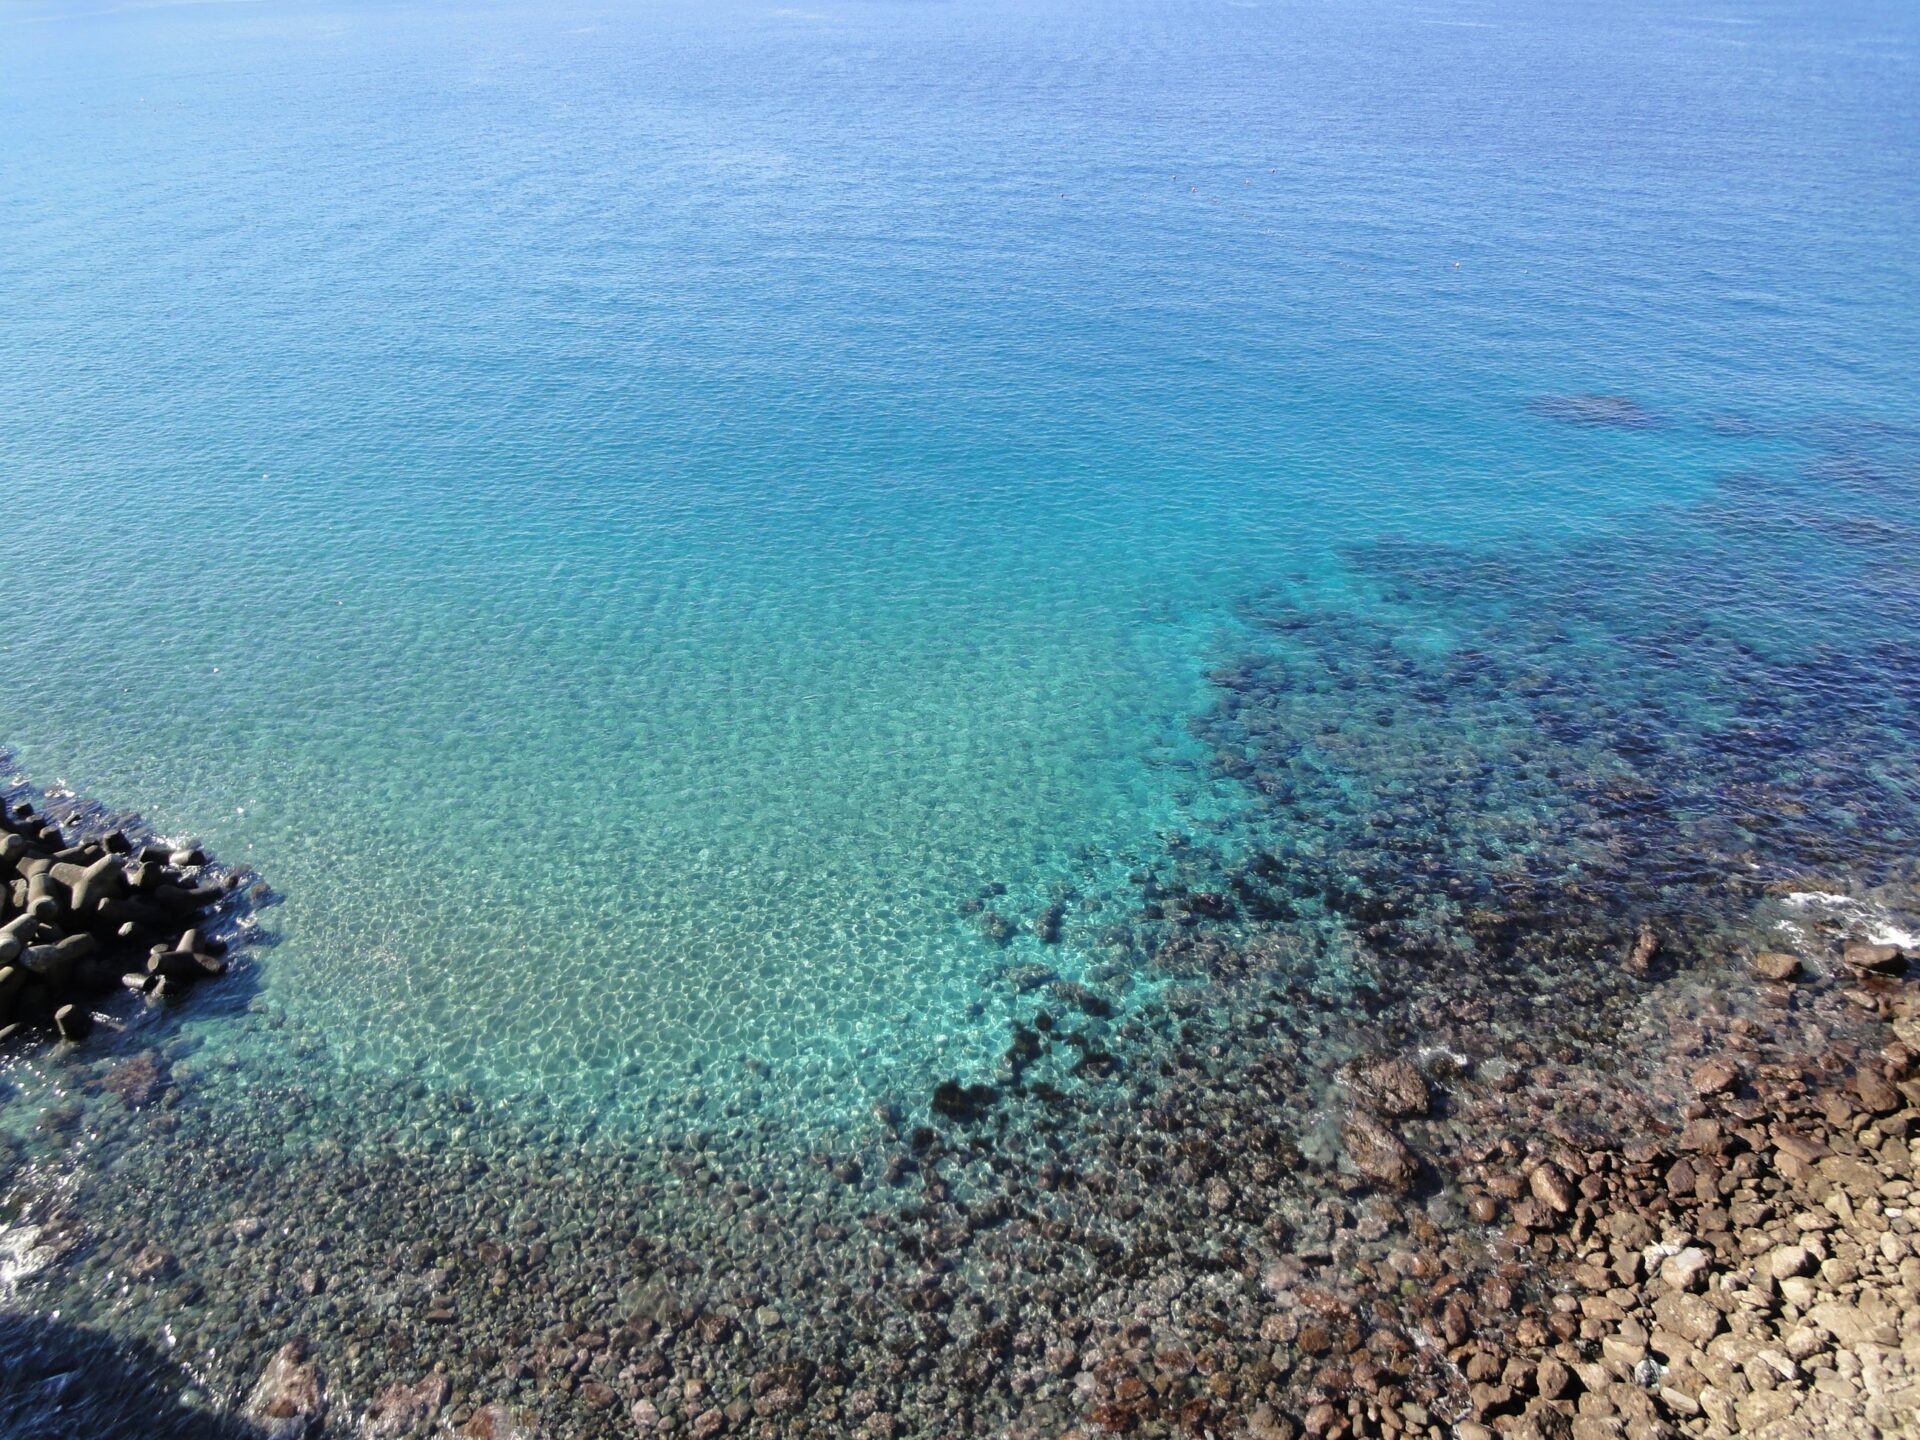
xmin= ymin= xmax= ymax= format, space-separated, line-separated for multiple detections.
xmin=0 ymin=801 xmax=244 ymax=1041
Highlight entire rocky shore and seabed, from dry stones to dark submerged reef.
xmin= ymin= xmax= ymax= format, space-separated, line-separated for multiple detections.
xmin=8 ymin=432 xmax=1920 ymax=1440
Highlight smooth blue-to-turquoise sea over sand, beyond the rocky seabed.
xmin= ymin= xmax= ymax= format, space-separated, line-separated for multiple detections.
xmin=0 ymin=2 xmax=1920 ymax=1125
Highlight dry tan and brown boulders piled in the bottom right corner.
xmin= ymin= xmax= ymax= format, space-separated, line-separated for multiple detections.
xmin=1440 ymin=968 xmax=1920 ymax=1440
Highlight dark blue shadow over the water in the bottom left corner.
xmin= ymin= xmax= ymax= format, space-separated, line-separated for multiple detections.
xmin=0 ymin=1313 xmax=265 ymax=1440
